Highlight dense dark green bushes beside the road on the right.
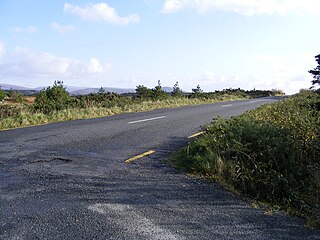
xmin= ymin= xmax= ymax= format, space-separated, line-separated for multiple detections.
xmin=175 ymin=91 xmax=320 ymax=227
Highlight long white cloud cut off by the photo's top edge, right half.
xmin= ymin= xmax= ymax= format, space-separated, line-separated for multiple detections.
xmin=162 ymin=0 xmax=320 ymax=16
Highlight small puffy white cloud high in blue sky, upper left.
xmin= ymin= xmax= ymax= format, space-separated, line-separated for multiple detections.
xmin=63 ymin=3 xmax=140 ymax=25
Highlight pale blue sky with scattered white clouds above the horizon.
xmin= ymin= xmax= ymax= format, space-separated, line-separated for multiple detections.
xmin=0 ymin=0 xmax=320 ymax=94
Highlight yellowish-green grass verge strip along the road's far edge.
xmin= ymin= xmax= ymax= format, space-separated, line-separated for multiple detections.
xmin=0 ymin=95 xmax=244 ymax=130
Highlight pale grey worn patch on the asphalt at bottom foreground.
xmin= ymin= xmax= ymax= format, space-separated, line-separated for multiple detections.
xmin=88 ymin=203 xmax=184 ymax=240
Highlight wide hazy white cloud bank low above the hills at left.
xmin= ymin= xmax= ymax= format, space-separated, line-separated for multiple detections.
xmin=0 ymin=47 xmax=110 ymax=79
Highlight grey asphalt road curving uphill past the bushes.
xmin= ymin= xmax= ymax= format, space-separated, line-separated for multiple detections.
xmin=0 ymin=97 xmax=320 ymax=239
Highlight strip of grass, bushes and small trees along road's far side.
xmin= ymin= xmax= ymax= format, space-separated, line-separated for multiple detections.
xmin=0 ymin=81 xmax=283 ymax=129
